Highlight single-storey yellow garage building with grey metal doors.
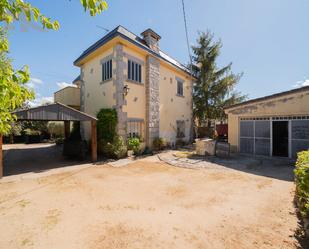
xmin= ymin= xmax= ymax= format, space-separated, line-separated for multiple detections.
xmin=225 ymin=86 xmax=309 ymax=158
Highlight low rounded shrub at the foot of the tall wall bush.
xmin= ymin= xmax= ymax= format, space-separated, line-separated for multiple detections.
xmin=98 ymin=136 xmax=127 ymax=159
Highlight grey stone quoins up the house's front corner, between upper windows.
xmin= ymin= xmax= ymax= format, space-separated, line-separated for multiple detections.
xmin=113 ymin=44 xmax=127 ymax=141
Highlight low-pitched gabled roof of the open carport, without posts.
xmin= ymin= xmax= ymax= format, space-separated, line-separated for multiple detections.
xmin=13 ymin=102 xmax=97 ymax=121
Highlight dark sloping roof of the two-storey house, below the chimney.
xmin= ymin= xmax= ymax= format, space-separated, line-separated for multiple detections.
xmin=74 ymin=26 xmax=190 ymax=74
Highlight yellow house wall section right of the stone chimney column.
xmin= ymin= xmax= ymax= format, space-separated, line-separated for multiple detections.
xmin=160 ymin=62 xmax=192 ymax=143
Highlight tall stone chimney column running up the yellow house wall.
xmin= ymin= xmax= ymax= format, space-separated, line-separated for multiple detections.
xmin=146 ymin=56 xmax=160 ymax=147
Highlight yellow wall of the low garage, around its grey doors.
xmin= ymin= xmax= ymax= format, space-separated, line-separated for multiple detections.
xmin=226 ymin=90 xmax=309 ymax=152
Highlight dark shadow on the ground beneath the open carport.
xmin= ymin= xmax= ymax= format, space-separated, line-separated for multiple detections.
xmin=4 ymin=144 xmax=90 ymax=176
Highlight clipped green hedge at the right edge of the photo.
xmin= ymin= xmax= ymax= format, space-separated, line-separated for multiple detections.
xmin=294 ymin=150 xmax=309 ymax=218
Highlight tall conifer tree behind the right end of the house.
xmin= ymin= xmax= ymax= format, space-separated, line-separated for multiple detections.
xmin=192 ymin=32 xmax=246 ymax=127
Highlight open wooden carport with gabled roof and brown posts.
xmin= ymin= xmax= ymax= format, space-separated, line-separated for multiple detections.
xmin=0 ymin=103 xmax=97 ymax=178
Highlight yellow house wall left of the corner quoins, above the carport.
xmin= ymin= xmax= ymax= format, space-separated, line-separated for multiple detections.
xmin=83 ymin=48 xmax=116 ymax=139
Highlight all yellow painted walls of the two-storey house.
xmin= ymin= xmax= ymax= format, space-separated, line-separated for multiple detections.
xmin=74 ymin=38 xmax=192 ymax=143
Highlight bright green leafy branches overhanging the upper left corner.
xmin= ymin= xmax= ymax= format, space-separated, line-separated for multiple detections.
xmin=0 ymin=0 xmax=107 ymax=136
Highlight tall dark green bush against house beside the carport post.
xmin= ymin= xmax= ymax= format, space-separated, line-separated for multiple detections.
xmin=97 ymin=109 xmax=127 ymax=159
